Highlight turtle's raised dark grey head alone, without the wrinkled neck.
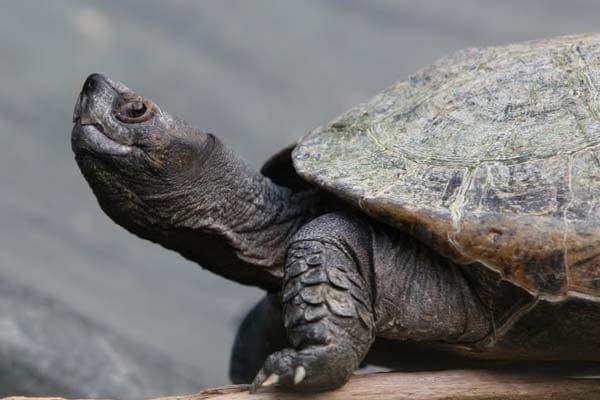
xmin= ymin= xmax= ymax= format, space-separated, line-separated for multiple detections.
xmin=71 ymin=74 xmax=214 ymax=233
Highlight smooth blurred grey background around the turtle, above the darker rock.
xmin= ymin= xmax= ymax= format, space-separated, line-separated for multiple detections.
xmin=0 ymin=0 xmax=600 ymax=396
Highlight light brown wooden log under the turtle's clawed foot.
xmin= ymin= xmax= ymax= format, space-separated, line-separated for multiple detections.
xmin=3 ymin=370 xmax=600 ymax=400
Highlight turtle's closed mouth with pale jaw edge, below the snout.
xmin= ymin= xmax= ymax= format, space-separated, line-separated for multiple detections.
xmin=71 ymin=118 xmax=133 ymax=156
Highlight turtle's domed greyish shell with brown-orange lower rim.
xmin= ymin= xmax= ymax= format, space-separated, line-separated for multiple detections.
xmin=292 ymin=34 xmax=600 ymax=301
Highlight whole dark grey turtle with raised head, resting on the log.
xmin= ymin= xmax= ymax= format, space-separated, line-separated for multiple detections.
xmin=72 ymin=33 xmax=600 ymax=392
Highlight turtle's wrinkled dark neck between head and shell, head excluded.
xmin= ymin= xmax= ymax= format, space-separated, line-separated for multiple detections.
xmin=146 ymin=138 xmax=317 ymax=289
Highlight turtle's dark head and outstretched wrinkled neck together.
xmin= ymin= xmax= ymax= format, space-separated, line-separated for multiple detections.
xmin=71 ymin=74 xmax=312 ymax=289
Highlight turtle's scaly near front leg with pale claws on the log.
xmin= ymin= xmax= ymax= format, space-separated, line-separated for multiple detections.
xmin=251 ymin=214 xmax=375 ymax=392
